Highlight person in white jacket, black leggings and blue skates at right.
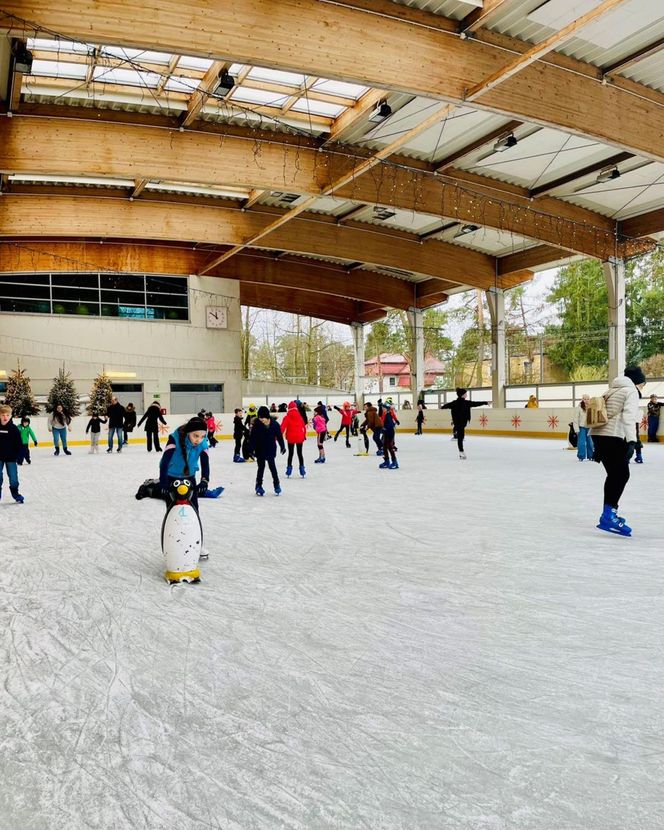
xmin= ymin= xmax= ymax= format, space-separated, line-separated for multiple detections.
xmin=590 ymin=366 xmax=646 ymax=536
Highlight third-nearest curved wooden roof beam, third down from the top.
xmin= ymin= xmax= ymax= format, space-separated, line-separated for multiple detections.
xmin=0 ymin=194 xmax=514 ymax=290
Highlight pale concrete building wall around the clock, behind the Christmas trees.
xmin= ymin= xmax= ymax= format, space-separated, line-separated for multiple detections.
xmin=0 ymin=276 xmax=242 ymax=417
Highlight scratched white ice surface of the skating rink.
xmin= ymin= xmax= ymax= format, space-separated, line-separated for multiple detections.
xmin=0 ymin=435 xmax=664 ymax=830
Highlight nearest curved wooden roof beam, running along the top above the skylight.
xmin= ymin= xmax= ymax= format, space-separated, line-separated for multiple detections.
xmin=6 ymin=0 xmax=664 ymax=161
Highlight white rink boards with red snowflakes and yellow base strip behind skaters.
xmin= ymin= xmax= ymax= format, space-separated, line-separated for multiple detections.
xmin=16 ymin=410 xmax=664 ymax=448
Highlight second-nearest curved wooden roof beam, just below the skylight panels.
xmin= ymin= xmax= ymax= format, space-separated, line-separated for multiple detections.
xmin=0 ymin=117 xmax=642 ymax=260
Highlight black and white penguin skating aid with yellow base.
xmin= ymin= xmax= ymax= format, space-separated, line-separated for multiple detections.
xmin=161 ymin=478 xmax=203 ymax=584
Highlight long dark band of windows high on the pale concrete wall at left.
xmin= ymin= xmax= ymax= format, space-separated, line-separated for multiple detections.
xmin=0 ymin=274 xmax=189 ymax=320
